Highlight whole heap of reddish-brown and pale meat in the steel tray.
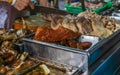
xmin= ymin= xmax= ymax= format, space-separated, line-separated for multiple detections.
xmin=34 ymin=10 xmax=120 ymax=50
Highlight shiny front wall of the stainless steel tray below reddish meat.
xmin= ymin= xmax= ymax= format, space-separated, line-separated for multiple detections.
xmin=24 ymin=39 xmax=88 ymax=75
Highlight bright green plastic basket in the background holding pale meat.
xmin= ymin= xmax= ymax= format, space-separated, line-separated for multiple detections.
xmin=65 ymin=2 xmax=113 ymax=14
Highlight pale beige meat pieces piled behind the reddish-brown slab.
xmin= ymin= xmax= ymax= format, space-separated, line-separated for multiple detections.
xmin=51 ymin=10 xmax=120 ymax=38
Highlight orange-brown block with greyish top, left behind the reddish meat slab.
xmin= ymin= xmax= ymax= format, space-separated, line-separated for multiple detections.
xmin=14 ymin=12 xmax=50 ymax=32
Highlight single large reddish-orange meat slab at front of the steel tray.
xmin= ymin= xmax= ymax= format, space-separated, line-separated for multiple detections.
xmin=34 ymin=26 xmax=80 ymax=43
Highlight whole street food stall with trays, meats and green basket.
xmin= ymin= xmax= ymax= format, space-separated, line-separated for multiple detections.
xmin=0 ymin=0 xmax=120 ymax=75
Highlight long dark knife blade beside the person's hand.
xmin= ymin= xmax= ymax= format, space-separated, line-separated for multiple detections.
xmin=34 ymin=6 xmax=69 ymax=15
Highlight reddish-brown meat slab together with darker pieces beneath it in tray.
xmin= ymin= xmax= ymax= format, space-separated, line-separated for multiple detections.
xmin=34 ymin=26 xmax=92 ymax=50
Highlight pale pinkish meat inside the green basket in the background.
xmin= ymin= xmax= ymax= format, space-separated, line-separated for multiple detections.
xmin=70 ymin=1 xmax=104 ymax=9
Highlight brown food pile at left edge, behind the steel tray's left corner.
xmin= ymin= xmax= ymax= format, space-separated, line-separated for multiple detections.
xmin=0 ymin=19 xmax=34 ymax=43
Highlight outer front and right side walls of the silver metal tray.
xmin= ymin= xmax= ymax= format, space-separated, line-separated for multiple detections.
xmin=23 ymin=30 xmax=120 ymax=72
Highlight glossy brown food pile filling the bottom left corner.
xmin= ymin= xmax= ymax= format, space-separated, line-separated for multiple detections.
xmin=0 ymin=41 xmax=50 ymax=75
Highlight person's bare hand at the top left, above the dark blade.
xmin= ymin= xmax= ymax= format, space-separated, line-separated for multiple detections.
xmin=14 ymin=0 xmax=34 ymax=11
